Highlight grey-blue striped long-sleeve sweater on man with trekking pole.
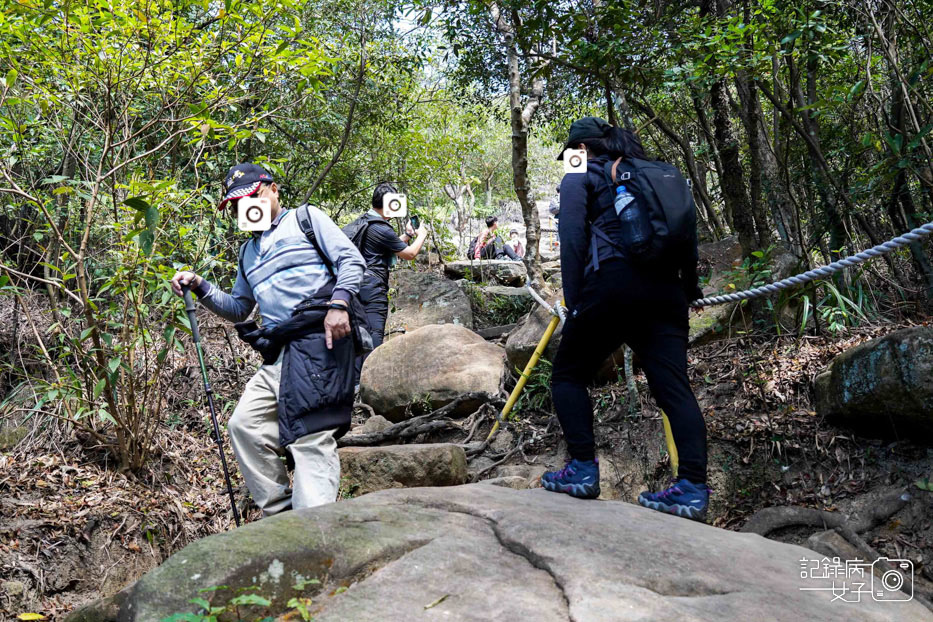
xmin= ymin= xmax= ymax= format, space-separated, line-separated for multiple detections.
xmin=193 ymin=207 xmax=366 ymax=327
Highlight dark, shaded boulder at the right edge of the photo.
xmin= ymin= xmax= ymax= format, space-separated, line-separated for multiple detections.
xmin=813 ymin=326 xmax=933 ymax=439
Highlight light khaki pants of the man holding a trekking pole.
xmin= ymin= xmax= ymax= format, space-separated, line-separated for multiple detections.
xmin=227 ymin=355 xmax=340 ymax=516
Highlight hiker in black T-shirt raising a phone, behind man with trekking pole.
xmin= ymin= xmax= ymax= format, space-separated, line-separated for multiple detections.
xmin=343 ymin=183 xmax=428 ymax=382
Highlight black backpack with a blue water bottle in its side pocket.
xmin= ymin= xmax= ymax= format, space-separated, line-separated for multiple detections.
xmin=603 ymin=158 xmax=697 ymax=264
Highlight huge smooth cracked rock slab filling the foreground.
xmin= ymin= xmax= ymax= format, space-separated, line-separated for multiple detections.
xmin=73 ymin=484 xmax=933 ymax=622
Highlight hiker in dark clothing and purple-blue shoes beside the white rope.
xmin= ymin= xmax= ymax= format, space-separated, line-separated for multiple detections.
xmin=542 ymin=117 xmax=709 ymax=520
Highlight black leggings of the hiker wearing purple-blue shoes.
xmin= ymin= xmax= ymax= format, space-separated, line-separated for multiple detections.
xmin=551 ymin=260 xmax=706 ymax=484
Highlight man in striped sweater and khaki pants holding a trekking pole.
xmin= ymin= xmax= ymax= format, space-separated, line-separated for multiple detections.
xmin=171 ymin=164 xmax=365 ymax=516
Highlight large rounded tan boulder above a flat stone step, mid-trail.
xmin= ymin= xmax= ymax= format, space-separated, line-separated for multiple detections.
xmin=360 ymin=324 xmax=505 ymax=422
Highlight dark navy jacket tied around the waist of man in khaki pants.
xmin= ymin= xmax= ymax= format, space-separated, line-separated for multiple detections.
xmin=235 ymin=292 xmax=372 ymax=447
